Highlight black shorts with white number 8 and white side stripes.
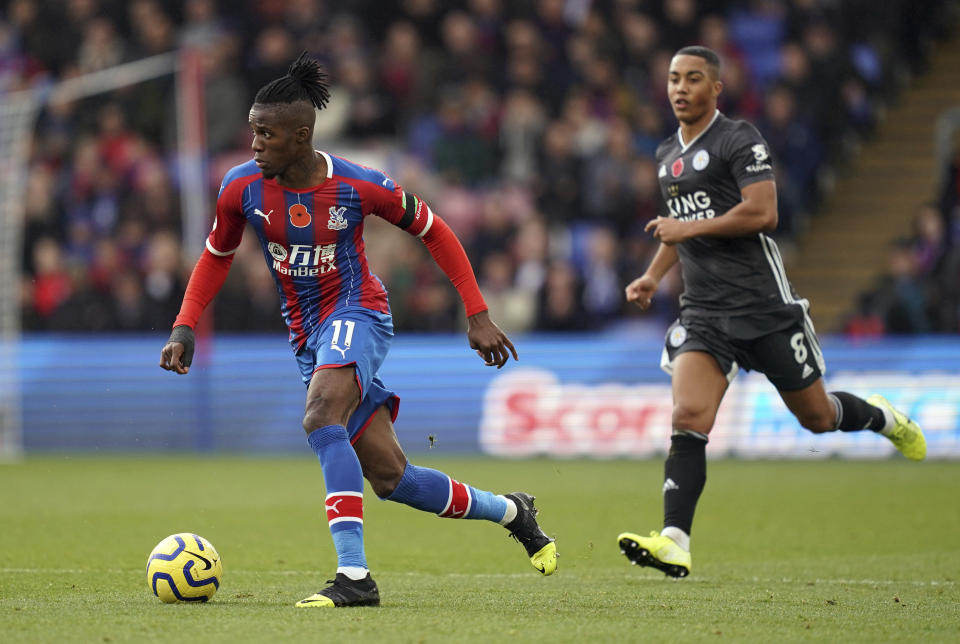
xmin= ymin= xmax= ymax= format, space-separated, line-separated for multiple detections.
xmin=660 ymin=300 xmax=826 ymax=391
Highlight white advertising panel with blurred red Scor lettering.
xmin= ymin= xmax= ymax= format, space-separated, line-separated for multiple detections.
xmin=480 ymin=369 xmax=960 ymax=458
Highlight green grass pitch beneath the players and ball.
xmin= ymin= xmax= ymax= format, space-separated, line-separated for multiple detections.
xmin=0 ymin=457 xmax=960 ymax=643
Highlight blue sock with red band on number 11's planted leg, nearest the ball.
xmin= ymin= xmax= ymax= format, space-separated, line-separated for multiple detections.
xmin=307 ymin=425 xmax=367 ymax=576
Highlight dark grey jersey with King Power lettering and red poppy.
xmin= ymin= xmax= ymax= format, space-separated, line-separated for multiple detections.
xmin=656 ymin=111 xmax=795 ymax=316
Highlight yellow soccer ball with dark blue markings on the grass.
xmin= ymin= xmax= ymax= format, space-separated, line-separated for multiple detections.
xmin=147 ymin=532 xmax=223 ymax=604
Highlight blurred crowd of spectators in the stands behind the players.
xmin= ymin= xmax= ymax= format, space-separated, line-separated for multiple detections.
xmin=0 ymin=0 xmax=960 ymax=332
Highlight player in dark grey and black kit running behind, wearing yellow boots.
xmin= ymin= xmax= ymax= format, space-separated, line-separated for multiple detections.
xmin=617 ymin=47 xmax=927 ymax=577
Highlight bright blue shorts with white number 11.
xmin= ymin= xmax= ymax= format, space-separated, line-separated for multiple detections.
xmin=296 ymin=307 xmax=400 ymax=443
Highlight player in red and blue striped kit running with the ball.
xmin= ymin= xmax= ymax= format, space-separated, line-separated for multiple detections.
xmin=160 ymin=54 xmax=557 ymax=607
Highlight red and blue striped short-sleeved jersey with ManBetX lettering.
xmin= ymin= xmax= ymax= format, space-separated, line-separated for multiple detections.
xmin=207 ymin=152 xmax=434 ymax=347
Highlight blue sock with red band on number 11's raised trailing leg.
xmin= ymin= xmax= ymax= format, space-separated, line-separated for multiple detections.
xmin=386 ymin=463 xmax=507 ymax=523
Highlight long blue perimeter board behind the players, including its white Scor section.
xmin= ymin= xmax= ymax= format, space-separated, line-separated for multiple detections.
xmin=13 ymin=333 xmax=960 ymax=458
